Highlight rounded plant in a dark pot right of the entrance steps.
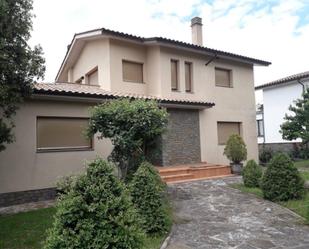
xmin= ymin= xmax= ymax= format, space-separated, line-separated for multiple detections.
xmin=223 ymin=134 xmax=247 ymax=174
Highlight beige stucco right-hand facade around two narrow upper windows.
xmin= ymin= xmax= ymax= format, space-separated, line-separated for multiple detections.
xmin=156 ymin=49 xmax=258 ymax=164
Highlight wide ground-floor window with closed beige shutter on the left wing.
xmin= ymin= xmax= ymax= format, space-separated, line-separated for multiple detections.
xmin=36 ymin=117 xmax=92 ymax=151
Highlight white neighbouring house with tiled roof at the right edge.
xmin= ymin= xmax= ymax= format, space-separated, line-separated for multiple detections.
xmin=255 ymin=71 xmax=309 ymax=152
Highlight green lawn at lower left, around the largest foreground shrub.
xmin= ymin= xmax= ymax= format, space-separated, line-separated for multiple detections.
xmin=0 ymin=208 xmax=165 ymax=249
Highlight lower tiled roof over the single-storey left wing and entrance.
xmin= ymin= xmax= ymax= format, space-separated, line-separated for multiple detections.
xmin=34 ymin=83 xmax=215 ymax=107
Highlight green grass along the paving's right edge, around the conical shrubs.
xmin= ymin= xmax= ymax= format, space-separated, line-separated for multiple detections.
xmin=230 ymin=183 xmax=309 ymax=224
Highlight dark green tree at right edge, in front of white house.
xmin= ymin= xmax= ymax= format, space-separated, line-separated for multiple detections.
xmin=280 ymin=89 xmax=309 ymax=148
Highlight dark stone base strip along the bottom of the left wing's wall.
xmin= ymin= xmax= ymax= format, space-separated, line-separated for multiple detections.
xmin=0 ymin=188 xmax=57 ymax=207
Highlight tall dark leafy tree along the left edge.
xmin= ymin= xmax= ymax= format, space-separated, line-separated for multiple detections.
xmin=0 ymin=0 xmax=45 ymax=151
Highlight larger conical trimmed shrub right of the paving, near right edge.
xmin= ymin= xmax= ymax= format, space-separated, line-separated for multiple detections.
xmin=262 ymin=153 xmax=304 ymax=201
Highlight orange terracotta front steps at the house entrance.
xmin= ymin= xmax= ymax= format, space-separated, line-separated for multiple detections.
xmin=157 ymin=163 xmax=232 ymax=183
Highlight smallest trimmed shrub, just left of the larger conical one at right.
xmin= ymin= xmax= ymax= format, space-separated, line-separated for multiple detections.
xmin=242 ymin=160 xmax=263 ymax=188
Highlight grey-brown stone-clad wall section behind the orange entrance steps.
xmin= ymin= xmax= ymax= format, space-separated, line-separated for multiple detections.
xmin=161 ymin=109 xmax=201 ymax=166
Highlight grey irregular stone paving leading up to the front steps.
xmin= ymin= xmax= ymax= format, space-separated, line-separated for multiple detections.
xmin=167 ymin=177 xmax=309 ymax=249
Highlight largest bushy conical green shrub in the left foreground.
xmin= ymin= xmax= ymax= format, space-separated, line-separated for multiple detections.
xmin=45 ymin=159 xmax=144 ymax=249
